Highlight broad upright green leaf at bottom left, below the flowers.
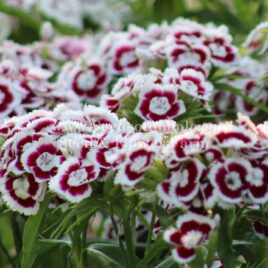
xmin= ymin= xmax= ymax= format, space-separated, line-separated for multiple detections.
xmin=21 ymin=194 xmax=52 ymax=268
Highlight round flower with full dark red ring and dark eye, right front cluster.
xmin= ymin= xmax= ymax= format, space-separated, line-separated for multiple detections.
xmin=208 ymin=158 xmax=252 ymax=203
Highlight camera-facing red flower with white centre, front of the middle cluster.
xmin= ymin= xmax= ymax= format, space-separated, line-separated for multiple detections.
xmin=135 ymin=84 xmax=186 ymax=121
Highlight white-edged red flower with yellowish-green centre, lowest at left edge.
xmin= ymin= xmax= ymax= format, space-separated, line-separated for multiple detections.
xmin=1 ymin=174 xmax=46 ymax=215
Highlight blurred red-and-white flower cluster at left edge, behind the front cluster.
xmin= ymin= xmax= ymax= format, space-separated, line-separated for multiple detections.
xmin=0 ymin=60 xmax=80 ymax=118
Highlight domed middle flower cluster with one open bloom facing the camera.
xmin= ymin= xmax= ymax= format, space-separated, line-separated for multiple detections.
xmin=101 ymin=68 xmax=213 ymax=121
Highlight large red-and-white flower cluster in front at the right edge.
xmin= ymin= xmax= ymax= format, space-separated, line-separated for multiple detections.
xmin=158 ymin=115 xmax=268 ymax=210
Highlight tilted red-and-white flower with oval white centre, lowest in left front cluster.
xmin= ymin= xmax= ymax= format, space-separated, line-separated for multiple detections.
xmin=49 ymin=158 xmax=99 ymax=203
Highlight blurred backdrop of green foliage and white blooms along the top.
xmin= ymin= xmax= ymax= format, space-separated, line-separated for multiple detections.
xmin=0 ymin=0 xmax=268 ymax=43
